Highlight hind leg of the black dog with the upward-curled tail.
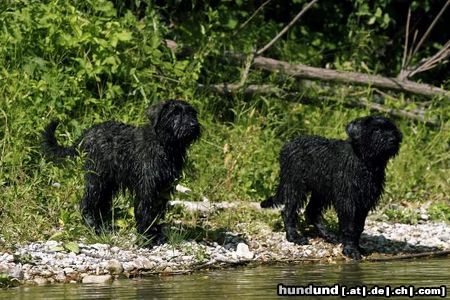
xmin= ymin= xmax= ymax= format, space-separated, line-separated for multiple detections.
xmin=80 ymin=173 xmax=117 ymax=234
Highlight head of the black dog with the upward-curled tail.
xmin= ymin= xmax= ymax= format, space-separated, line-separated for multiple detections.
xmin=147 ymin=100 xmax=200 ymax=145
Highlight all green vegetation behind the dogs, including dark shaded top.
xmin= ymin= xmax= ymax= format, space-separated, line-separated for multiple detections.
xmin=0 ymin=0 xmax=450 ymax=248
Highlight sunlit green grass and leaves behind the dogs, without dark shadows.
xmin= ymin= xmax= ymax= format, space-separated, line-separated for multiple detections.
xmin=0 ymin=0 xmax=450 ymax=248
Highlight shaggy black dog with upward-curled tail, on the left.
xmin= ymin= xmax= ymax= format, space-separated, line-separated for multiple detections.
xmin=43 ymin=100 xmax=200 ymax=243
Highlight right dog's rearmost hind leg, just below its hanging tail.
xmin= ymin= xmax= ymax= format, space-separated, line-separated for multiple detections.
xmin=282 ymin=184 xmax=308 ymax=245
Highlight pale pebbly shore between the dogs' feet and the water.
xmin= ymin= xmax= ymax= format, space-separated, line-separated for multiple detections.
xmin=0 ymin=202 xmax=450 ymax=285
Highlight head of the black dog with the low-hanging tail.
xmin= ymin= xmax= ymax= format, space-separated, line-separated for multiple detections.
xmin=346 ymin=116 xmax=402 ymax=161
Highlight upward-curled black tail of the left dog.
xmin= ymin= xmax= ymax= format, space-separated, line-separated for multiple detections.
xmin=42 ymin=120 xmax=78 ymax=158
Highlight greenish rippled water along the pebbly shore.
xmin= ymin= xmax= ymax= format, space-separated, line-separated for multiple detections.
xmin=0 ymin=258 xmax=450 ymax=300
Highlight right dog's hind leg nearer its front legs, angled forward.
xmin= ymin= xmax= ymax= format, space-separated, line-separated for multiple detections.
xmin=305 ymin=192 xmax=336 ymax=243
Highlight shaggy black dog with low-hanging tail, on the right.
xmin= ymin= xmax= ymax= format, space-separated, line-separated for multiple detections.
xmin=261 ymin=116 xmax=402 ymax=259
